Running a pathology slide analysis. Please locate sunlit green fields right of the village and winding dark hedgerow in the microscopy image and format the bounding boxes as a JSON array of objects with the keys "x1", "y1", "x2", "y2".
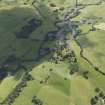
[{"x1": 73, "y1": 4, "x2": 105, "y2": 71}]
